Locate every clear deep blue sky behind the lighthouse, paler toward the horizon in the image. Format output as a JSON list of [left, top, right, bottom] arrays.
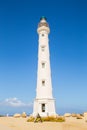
[[0, 0, 87, 114]]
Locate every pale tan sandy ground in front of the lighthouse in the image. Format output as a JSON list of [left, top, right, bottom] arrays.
[[0, 117, 87, 130]]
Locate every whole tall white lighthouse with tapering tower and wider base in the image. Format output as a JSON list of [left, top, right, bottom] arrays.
[[33, 17, 56, 116]]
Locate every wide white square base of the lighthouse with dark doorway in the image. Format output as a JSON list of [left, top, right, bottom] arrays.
[[32, 99, 56, 117]]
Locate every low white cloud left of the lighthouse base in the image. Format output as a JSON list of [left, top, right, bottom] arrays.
[[0, 97, 32, 107]]
